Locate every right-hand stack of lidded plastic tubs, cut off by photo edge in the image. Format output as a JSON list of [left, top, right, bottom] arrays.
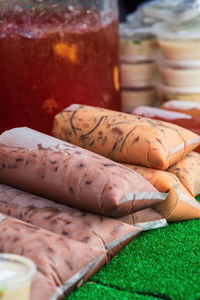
[[153, 18, 200, 102]]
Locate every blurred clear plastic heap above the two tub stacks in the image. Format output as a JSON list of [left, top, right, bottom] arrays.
[[127, 0, 200, 27]]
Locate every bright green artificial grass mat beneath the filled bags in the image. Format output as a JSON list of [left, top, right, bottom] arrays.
[[66, 196, 200, 300]]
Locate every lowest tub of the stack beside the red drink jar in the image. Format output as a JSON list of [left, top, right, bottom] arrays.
[[121, 88, 157, 113]]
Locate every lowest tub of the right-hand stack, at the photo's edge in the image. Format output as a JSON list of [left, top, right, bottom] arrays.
[[156, 84, 200, 103]]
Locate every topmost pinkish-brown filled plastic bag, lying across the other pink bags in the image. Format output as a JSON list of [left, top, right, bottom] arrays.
[[0, 125, 166, 217]]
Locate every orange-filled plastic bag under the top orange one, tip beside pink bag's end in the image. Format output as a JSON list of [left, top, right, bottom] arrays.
[[123, 164, 200, 222]]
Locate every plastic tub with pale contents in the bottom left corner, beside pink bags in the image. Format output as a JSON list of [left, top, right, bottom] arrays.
[[0, 254, 36, 300]]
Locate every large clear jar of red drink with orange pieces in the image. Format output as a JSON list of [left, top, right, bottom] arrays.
[[0, 0, 120, 134]]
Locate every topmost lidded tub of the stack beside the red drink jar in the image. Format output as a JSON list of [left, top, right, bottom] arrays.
[[120, 24, 158, 62]]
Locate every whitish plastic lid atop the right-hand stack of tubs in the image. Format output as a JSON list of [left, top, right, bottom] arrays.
[[152, 17, 200, 40]]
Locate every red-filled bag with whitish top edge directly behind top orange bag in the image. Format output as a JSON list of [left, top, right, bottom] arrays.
[[133, 106, 200, 135]]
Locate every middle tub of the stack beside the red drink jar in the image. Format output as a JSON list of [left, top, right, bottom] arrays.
[[120, 61, 157, 88]]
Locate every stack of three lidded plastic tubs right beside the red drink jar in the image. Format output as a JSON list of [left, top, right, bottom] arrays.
[[120, 24, 158, 113]]
